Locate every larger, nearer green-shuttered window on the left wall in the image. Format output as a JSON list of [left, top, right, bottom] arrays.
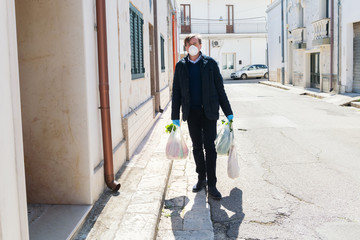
[[130, 4, 145, 79]]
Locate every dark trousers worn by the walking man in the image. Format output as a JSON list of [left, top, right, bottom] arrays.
[[188, 109, 217, 186]]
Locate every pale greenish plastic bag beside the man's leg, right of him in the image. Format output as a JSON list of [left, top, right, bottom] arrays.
[[215, 121, 234, 155]]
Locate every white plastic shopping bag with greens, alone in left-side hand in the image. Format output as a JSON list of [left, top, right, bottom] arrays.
[[166, 127, 189, 159]]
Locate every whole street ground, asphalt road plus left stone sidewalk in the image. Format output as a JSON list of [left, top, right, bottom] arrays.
[[74, 80, 360, 240]]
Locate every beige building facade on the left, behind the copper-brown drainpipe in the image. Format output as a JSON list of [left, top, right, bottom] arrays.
[[0, 0, 177, 239]]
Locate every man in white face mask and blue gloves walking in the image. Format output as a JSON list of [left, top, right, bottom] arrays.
[[171, 34, 233, 200]]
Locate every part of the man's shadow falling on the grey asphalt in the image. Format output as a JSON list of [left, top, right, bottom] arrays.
[[209, 187, 245, 239]]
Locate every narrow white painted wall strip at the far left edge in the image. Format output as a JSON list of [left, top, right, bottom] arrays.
[[0, 0, 29, 240]]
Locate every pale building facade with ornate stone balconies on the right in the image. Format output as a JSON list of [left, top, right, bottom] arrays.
[[267, 0, 360, 93]]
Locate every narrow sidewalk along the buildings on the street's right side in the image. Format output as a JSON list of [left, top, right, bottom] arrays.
[[259, 81, 360, 108]]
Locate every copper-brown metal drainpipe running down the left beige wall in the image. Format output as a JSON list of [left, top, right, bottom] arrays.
[[96, 0, 121, 192]]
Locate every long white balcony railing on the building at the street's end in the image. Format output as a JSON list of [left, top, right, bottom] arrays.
[[181, 21, 266, 34]]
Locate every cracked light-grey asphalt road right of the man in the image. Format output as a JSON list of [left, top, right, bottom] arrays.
[[209, 79, 360, 239]]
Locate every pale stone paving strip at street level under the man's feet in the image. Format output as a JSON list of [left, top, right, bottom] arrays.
[[157, 122, 214, 240]]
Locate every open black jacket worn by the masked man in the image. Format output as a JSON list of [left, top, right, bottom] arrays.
[[171, 55, 233, 121]]
